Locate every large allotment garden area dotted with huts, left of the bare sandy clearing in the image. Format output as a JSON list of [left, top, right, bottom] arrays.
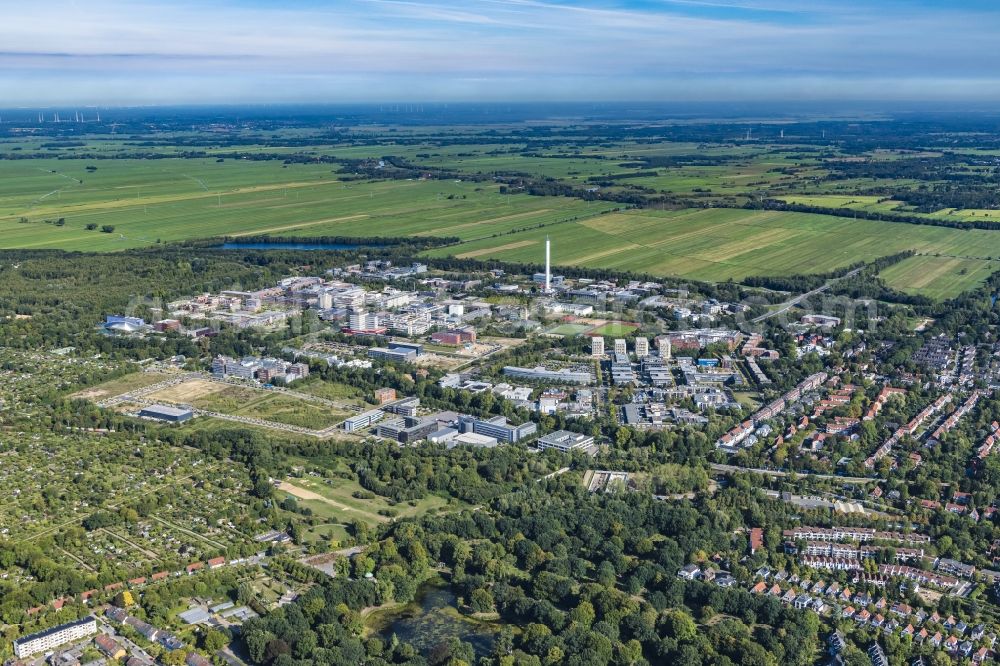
[[0, 436, 257, 576]]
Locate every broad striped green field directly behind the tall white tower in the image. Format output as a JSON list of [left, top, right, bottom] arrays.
[[428, 209, 1000, 290]]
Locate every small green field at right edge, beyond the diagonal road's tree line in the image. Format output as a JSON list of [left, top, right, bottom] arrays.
[[880, 255, 1000, 299]]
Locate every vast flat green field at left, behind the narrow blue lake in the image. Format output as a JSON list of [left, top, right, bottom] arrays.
[[0, 159, 613, 251]]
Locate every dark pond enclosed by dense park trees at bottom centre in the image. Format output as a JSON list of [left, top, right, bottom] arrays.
[[378, 584, 496, 657]]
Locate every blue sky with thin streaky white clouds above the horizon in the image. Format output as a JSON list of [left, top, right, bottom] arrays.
[[0, 0, 1000, 107]]
